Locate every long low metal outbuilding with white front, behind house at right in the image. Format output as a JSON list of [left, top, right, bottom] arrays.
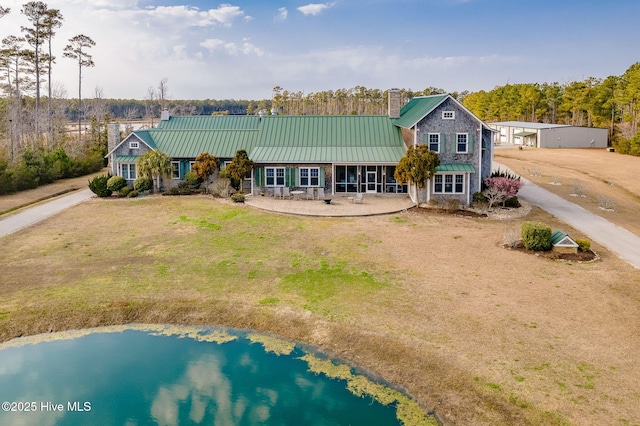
[[489, 121, 608, 148]]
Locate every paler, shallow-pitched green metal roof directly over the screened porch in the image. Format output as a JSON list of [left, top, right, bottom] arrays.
[[249, 146, 405, 164]]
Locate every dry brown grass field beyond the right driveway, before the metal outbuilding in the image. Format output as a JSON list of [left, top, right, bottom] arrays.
[[495, 148, 640, 235]]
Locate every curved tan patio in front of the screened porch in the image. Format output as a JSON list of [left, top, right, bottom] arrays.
[[245, 194, 415, 217]]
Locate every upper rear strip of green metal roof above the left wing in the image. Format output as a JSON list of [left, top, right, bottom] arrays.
[[156, 115, 260, 130]]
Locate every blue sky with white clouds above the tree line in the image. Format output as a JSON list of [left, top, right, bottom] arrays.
[[0, 0, 640, 99]]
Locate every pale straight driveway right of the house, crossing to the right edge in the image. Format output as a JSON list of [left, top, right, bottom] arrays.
[[493, 162, 640, 269]]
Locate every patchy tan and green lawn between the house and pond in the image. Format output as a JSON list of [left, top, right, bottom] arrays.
[[0, 196, 640, 425]]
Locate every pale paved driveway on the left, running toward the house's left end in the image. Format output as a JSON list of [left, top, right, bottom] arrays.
[[0, 189, 94, 238]]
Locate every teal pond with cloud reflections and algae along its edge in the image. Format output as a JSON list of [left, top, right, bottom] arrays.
[[0, 326, 420, 426]]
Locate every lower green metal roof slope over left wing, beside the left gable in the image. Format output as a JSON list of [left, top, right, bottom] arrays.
[[149, 129, 258, 158]]
